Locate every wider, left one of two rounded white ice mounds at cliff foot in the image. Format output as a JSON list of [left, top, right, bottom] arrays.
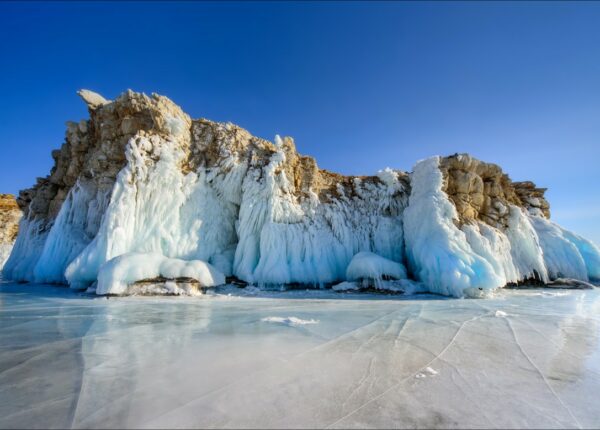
[[96, 252, 225, 294]]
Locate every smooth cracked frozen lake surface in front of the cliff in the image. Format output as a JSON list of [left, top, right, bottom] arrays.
[[0, 283, 600, 428]]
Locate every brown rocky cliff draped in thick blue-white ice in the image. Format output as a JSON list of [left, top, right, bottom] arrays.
[[4, 91, 600, 297]]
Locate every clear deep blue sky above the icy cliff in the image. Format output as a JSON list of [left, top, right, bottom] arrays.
[[0, 2, 600, 243]]
